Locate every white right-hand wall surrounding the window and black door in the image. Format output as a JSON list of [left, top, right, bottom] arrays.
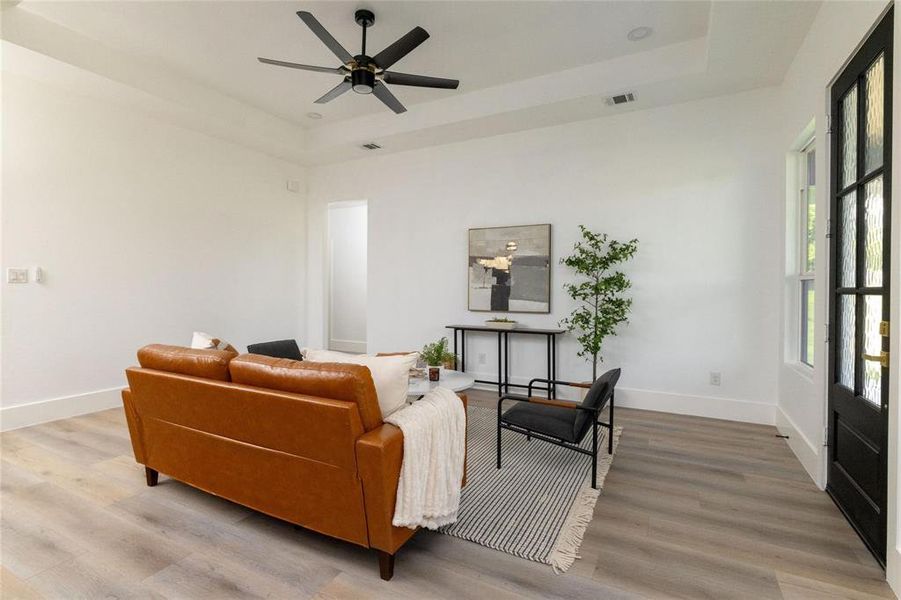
[[777, 0, 901, 593]]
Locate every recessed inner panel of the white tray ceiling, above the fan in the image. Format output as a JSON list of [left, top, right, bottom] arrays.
[[22, 1, 710, 126]]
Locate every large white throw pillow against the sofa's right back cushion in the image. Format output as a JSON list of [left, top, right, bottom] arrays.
[[303, 348, 419, 418]]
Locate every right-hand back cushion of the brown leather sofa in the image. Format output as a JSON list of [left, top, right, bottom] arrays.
[[229, 354, 382, 431]]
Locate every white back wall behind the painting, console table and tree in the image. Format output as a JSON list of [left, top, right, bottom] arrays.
[[308, 89, 783, 422]]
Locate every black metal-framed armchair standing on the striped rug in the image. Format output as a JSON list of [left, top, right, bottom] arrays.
[[497, 369, 621, 489]]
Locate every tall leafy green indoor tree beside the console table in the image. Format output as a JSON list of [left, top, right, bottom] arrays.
[[560, 225, 638, 381]]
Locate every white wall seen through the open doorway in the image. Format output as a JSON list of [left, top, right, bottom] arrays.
[[328, 201, 367, 352]]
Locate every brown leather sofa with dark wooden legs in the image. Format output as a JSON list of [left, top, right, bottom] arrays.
[[122, 345, 466, 580]]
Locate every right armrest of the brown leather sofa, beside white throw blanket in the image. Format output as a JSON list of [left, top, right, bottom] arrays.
[[357, 423, 416, 554]]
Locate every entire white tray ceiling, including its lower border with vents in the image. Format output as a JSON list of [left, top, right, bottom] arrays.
[[2, 0, 819, 163]]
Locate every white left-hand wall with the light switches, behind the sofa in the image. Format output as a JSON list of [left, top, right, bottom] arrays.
[[2, 68, 306, 428]]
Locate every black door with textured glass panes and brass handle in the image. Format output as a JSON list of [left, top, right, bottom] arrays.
[[826, 9, 894, 565]]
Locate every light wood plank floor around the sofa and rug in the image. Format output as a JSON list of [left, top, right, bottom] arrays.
[[0, 392, 892, 600]]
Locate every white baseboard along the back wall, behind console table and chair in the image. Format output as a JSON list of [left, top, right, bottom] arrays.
[[468, 371, 776, 425]]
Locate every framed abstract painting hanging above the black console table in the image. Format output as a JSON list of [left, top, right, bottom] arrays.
[[469, 225, 551, 313]]
